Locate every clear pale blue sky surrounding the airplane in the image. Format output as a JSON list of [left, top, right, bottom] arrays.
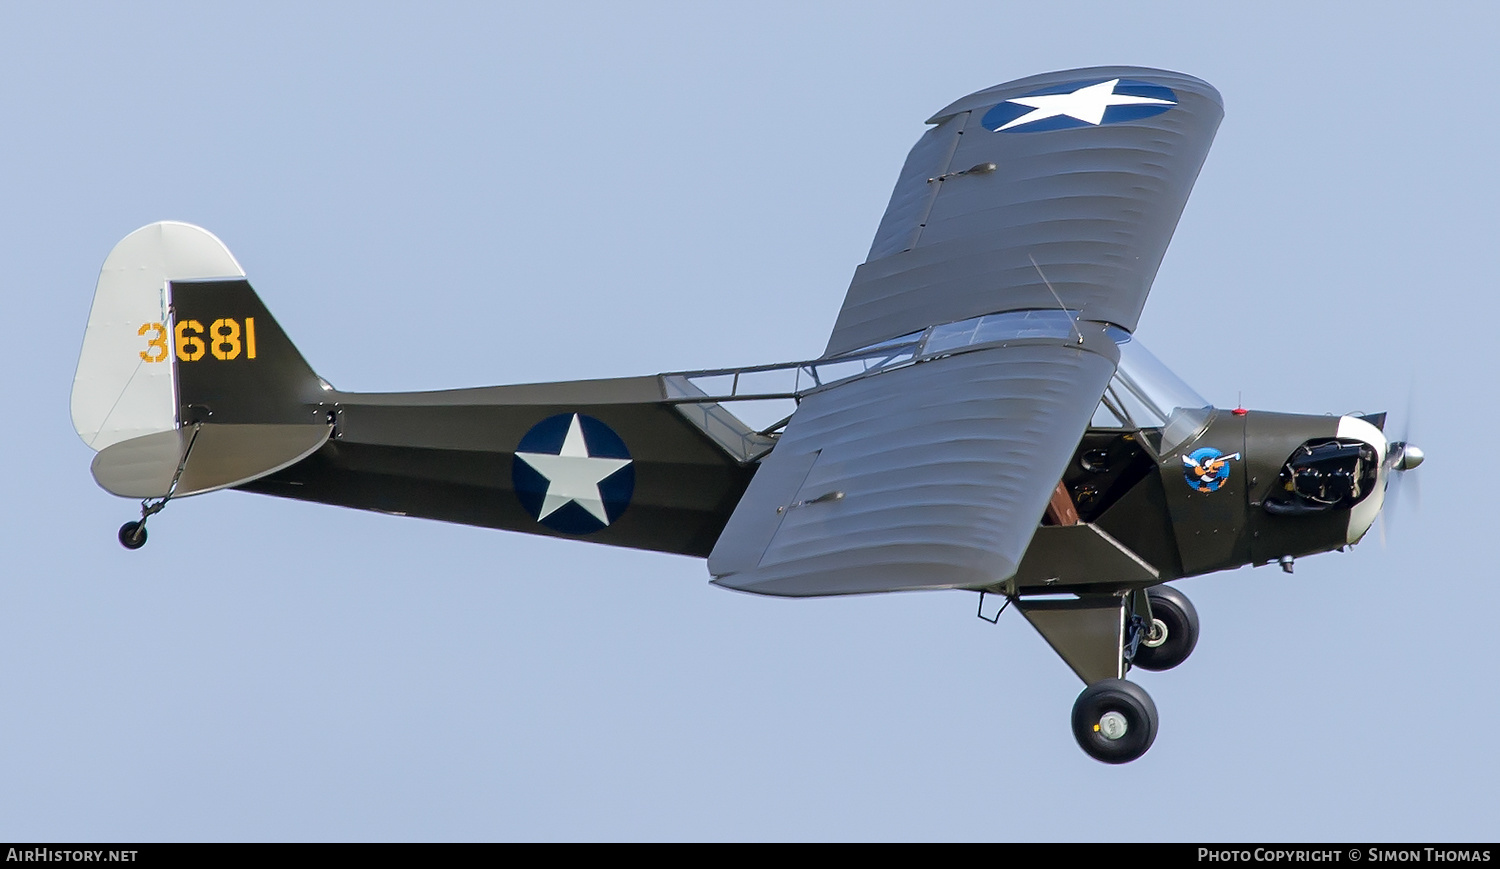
[[0, 3, 1500, 840]]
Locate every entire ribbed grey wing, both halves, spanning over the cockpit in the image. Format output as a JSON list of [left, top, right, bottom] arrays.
[[708, 68, 1223, 596]]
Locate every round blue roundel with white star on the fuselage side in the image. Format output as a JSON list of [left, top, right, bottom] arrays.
[[510, 413, 636, 534]]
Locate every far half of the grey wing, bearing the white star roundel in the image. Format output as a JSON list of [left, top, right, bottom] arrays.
[[827, 66, 1224, 354]]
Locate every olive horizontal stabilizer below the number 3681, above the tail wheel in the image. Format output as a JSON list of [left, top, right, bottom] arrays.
[[90, 423, 333, 498]]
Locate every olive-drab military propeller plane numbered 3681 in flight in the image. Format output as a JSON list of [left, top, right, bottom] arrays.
[[72, 66, 1424, 764]]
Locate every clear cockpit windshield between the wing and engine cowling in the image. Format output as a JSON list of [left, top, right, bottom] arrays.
[[1092, 336, 1214, 455]]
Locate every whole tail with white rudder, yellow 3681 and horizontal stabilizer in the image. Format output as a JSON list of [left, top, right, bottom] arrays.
[[72, 222, 329, 498]]
